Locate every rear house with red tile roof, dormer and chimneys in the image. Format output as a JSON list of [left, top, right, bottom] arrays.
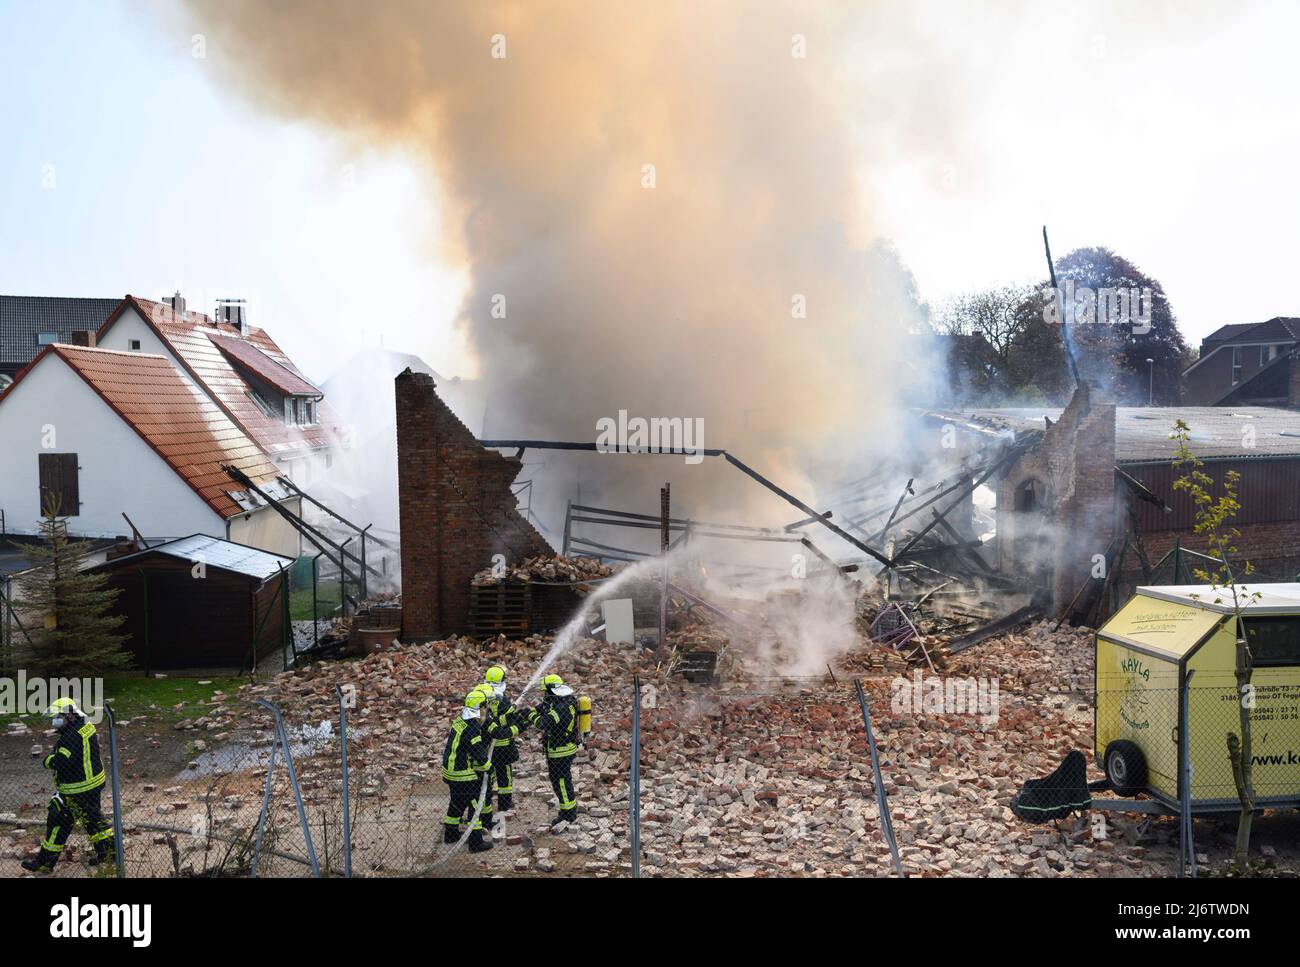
[[95, 294, 342, 486]]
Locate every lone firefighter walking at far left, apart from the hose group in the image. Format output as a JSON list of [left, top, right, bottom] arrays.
[[22, 698, 113, 873]]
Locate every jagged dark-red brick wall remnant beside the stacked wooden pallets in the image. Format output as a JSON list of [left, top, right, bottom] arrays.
[[394, 369, 554, 641]]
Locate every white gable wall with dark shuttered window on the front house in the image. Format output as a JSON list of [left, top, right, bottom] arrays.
[[0, 354, 225, 539]]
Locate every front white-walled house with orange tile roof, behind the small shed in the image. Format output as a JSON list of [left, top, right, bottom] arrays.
[[0, 343, 300, 556]]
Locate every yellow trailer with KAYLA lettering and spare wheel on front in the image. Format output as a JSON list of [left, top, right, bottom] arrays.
[[1093, 584, 1300, 812]]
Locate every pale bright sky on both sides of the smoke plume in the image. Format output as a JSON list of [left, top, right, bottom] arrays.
[[0, 0, 1300, 380]]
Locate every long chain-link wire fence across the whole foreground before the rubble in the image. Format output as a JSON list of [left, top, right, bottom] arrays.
[[20, 667, 1300, 877]]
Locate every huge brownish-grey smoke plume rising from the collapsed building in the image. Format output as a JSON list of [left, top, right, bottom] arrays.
[[175, 0, 946, 532]]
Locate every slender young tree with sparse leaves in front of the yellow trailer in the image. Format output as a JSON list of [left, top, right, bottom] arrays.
[[1170, 420, 1258, 872]]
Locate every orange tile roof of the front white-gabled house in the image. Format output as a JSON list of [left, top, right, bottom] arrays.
[[13, 346, 280, 517]]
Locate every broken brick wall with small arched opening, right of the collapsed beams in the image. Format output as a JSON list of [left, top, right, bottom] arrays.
[[997, 383, 1115, 613]]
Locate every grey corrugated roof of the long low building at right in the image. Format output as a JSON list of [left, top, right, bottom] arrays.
[[937, 407, 1300, 463]]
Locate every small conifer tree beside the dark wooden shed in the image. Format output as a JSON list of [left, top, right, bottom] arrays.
[[14, 498, 131, 676]]
